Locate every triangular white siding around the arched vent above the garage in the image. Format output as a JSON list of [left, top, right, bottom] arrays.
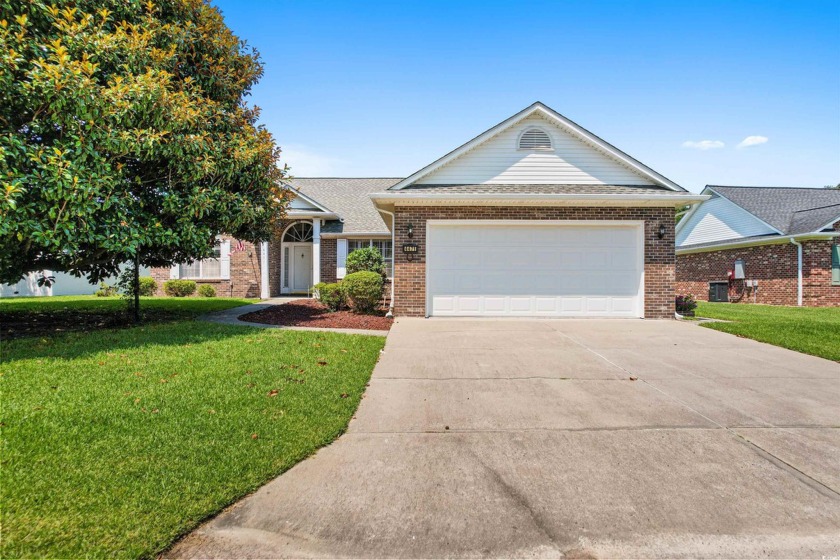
[[418, 116, 654, 185]]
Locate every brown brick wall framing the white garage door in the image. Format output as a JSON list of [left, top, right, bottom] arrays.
[[394, 206, 674, 319]]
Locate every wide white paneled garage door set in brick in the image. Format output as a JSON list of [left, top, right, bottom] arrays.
[[426, 220, 644, 317]]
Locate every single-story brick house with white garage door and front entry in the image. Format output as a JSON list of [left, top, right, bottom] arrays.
[[154, 102, 708, 318]]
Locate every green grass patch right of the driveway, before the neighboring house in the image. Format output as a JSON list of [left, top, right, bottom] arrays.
[[697, 302, 840, 362]]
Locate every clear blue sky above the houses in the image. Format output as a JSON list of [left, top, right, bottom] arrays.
[[214, 0, 840, 191]]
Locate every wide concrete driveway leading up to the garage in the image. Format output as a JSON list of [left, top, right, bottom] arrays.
[[169, 319, 840, 558]]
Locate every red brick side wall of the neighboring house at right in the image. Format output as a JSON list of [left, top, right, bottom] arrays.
[[676, 233, 840, 307]]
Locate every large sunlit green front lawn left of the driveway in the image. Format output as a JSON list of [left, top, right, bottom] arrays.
[[0, 304, 385, 558]]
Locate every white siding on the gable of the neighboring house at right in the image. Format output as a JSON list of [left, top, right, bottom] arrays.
[[676, 196, 777, 247]]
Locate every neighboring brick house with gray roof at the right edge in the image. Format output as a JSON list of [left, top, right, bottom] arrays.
[[676, 185, 840, 307]]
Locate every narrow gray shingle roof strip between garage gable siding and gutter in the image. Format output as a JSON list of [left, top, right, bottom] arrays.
[[398, 184, 680, 196]]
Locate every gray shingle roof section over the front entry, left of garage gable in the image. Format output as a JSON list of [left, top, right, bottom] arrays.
[[287, 177, 402, 234]]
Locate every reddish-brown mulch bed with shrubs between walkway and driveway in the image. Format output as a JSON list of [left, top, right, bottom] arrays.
[[239, 299, 394, 331]]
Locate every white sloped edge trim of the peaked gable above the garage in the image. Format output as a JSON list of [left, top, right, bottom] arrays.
[[389, 101, 686, 192]]
